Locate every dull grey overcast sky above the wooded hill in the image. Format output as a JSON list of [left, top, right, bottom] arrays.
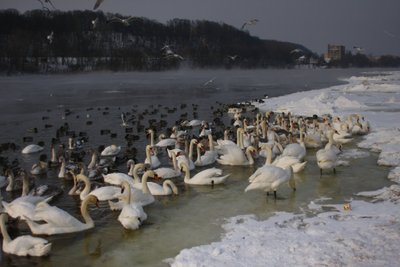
[[0, 0, 400, 56]]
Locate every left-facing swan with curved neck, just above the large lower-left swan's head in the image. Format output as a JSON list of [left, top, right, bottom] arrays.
[[76, 174, 121, 201]]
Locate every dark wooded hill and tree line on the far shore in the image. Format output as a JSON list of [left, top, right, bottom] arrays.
[[0, 9, 399, 73]]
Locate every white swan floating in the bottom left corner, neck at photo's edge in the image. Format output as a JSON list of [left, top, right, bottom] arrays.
[[0, 214, 51, 257]]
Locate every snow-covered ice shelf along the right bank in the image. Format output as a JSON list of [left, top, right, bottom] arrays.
[[166, 71, 400, 267]]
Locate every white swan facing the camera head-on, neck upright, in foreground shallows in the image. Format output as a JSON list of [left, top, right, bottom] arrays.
[[116, 181, 147, 230]]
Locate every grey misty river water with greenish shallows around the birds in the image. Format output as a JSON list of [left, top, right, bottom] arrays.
[[0, 69, 389, 266]]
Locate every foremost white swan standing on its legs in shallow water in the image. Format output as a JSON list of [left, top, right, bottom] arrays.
[[244, 166, 296, 199]]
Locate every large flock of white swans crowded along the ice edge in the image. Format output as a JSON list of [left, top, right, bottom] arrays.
[[0, 102, 369, 256]]
